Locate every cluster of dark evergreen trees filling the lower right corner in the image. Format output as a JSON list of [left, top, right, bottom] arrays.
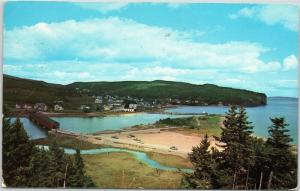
[[182, 106, 297, 189]]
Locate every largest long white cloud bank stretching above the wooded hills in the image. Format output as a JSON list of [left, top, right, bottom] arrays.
[[4, 17, 288, 73]]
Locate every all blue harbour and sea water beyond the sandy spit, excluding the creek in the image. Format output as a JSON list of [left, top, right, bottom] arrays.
[[18, 98, 298, 143]]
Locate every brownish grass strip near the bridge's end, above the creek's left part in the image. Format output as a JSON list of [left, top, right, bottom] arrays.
[[33, 134, 103, 150]]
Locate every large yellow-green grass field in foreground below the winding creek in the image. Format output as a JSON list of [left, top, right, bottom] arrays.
[[82, 153, 182, 189]]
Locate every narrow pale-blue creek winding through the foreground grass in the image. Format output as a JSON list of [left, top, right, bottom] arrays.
[[38, 146, 193, 173]]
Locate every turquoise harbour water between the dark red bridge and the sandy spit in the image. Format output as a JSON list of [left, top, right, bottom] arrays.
[[52, 113, 193, 134]]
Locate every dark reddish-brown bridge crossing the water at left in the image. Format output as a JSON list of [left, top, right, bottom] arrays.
[[29, 112, 59, 130]]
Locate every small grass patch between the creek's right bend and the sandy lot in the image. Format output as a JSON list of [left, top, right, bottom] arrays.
[[147, 152, 192, 168]]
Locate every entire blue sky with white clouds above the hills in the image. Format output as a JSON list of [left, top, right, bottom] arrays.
[[3, 2, 299, 97]]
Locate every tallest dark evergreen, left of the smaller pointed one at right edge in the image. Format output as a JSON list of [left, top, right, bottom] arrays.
[[216, 106, 254, 189]]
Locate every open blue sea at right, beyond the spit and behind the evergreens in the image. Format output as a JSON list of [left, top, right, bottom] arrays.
[[167, 97, 298, 143]]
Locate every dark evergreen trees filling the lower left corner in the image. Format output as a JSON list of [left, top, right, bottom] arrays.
[[2, 118, 94, 188]]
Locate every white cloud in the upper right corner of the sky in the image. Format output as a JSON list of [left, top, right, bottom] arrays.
[[229, 5, 299, 31]]
